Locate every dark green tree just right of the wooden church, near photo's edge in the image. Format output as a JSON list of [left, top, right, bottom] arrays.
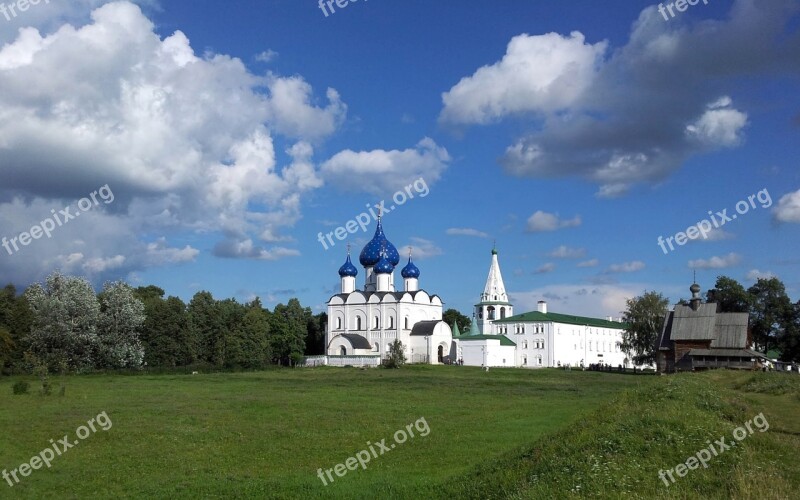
[[747, 278, 794, 353]]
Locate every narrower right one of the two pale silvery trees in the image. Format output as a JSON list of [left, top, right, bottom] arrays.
[[96, 281, 145, 368]]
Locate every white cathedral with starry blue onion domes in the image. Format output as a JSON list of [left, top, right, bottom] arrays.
[[325, 217, 453, 366]]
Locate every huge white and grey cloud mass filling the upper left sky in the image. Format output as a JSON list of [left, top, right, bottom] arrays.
[[0, 0, 347, 283]]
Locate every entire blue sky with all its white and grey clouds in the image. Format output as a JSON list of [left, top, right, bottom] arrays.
[[0, 0, 800, 317]]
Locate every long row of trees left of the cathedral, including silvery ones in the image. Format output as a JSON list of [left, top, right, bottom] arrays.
[[0, 272, 327, 374]]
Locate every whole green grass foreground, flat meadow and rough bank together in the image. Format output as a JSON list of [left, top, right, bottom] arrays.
[[0, 366, 800, 498]]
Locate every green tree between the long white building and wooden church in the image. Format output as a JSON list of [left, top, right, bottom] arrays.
[[620, 292, 669, 365]]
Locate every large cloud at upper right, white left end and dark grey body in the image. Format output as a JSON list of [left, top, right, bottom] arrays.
[[441, 0, 800, 198]]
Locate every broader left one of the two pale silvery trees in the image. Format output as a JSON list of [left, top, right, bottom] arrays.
[[24, 272, 100, 371]]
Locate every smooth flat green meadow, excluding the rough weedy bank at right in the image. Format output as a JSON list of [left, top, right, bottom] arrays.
[[0, 366, 658, 498]]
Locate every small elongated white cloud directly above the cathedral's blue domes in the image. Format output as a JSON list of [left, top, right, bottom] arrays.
[[321, 137, 450, 195]]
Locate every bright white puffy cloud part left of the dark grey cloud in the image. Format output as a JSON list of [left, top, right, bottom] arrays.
[[440, 31, 607, 123]]
